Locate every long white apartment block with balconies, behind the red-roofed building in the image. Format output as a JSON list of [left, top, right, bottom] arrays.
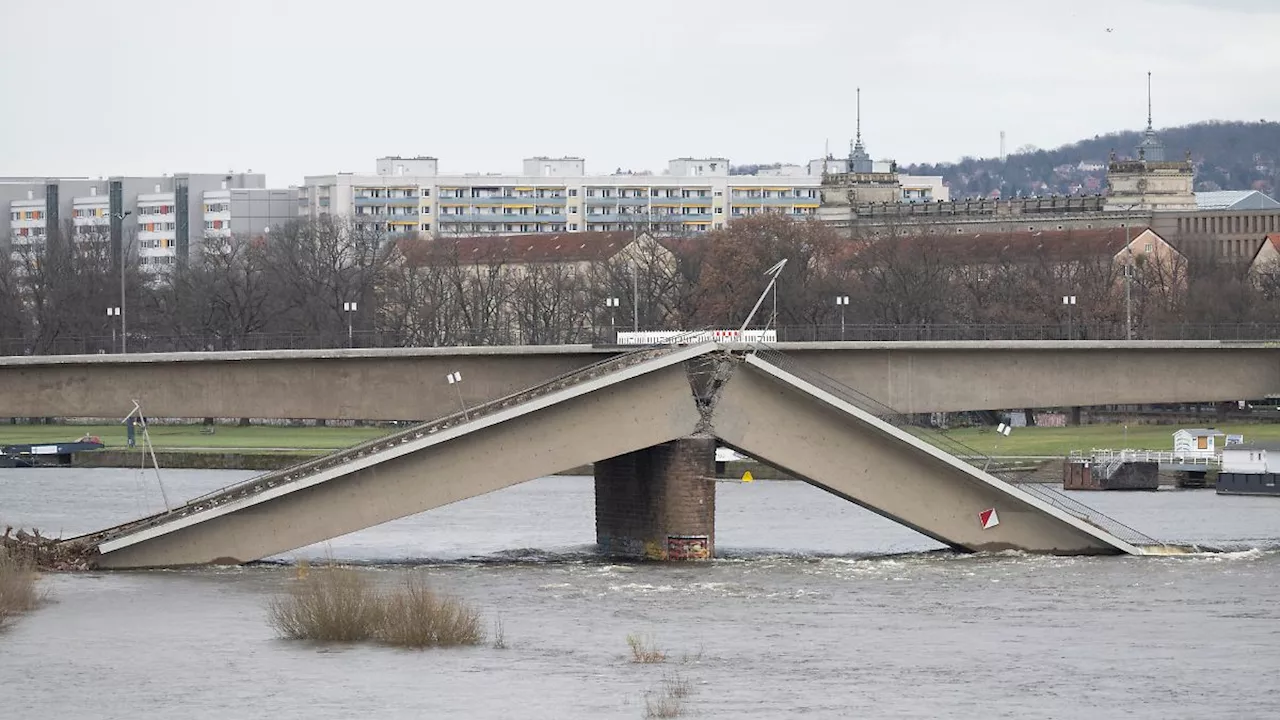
[[298, 158, 947, 236]]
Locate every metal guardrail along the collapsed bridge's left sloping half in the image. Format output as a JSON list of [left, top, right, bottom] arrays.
[[81, 331, 704, 544]]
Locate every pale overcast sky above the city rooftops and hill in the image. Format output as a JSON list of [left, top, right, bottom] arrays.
[[0, 0, 1280, 186]]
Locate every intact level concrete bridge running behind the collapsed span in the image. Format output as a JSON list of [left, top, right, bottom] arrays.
[[0, 341, 1280, 420]]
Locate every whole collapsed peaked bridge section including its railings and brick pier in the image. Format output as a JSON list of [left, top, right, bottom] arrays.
[[68, 343, 1158, 568]]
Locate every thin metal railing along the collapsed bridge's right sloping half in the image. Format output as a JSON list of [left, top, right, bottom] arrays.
[[754, 345, 1161, 546]]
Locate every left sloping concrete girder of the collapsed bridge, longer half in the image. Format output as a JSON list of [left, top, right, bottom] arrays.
[[97, 351, 701, 569]]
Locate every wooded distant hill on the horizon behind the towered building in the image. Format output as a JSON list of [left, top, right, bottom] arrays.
[[900, 120, 1280, 199]]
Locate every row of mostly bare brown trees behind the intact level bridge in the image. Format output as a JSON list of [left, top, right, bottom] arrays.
[[0, 214, 1280, 355]]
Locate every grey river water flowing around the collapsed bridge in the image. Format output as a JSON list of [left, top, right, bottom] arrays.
[[0, 469, 1280, 720]]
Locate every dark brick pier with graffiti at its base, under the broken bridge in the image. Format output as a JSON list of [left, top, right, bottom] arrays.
[[595, 438, 716, 560]]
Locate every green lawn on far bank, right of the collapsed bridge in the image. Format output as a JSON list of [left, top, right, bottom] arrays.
[[926, 423, 1280, 455]]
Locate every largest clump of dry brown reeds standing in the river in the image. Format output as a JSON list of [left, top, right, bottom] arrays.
[[268, 562, 485, 648]]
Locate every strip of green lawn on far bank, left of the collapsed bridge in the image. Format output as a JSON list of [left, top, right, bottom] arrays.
[[0, 424, 392, 450]]
